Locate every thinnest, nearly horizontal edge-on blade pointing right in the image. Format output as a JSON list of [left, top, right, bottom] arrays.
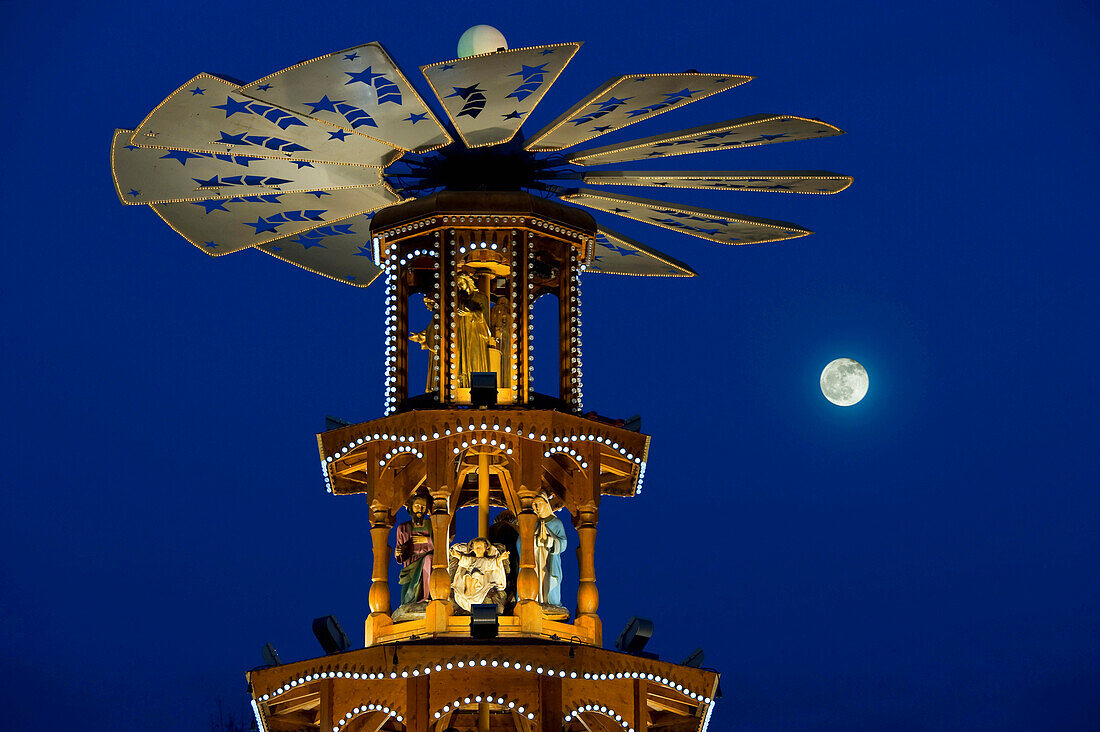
[[581, 171, 851, 195]]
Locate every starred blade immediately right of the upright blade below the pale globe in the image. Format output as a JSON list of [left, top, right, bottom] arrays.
[[525, 72, 752, 151]]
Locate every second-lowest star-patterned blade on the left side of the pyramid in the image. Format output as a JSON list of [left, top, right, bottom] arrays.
[[153, 184, 400, 256]]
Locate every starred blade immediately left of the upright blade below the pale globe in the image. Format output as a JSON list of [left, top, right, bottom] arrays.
[[240, 43, 451, 153]]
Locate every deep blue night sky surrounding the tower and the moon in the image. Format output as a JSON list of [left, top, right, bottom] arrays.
[[0, 0, 1100, 732]]
